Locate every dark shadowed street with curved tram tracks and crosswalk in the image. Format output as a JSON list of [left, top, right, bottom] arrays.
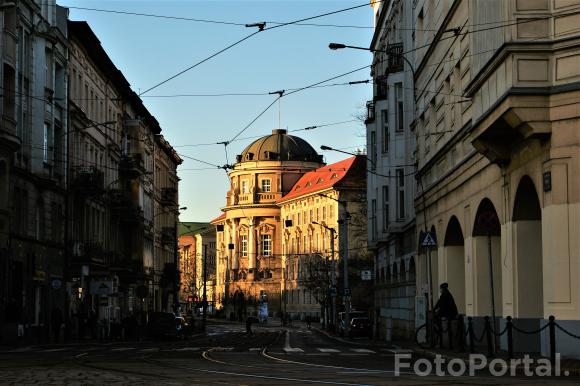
[[0, 324, 580, 386]]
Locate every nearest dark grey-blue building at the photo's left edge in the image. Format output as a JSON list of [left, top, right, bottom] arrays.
[[0, 1, 68, 341]]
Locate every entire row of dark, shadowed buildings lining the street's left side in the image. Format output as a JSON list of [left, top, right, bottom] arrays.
[[0, 5, 180, 341]]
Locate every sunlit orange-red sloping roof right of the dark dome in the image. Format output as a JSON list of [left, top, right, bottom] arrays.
[[276, 156, 366, 204]]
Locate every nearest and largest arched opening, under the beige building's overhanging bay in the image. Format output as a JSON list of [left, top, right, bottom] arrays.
[[512, 176, 544, 318]]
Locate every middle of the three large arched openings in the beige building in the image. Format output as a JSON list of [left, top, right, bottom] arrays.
[[472, 198, 503, 317]]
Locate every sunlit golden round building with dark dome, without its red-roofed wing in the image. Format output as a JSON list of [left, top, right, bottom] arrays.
[[212, 130, 324, 317]]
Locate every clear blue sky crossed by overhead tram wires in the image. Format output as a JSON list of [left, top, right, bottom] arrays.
[[57, 0, 373, 221]]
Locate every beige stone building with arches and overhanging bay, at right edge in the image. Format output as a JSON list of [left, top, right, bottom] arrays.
[[413, 0, 580, 356]]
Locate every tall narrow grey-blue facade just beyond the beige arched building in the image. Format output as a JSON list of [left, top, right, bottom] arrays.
[[365, 0, 416, 340]]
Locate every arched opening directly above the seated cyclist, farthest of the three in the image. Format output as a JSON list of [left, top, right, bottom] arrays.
[[443, 216, 465, 314]]
